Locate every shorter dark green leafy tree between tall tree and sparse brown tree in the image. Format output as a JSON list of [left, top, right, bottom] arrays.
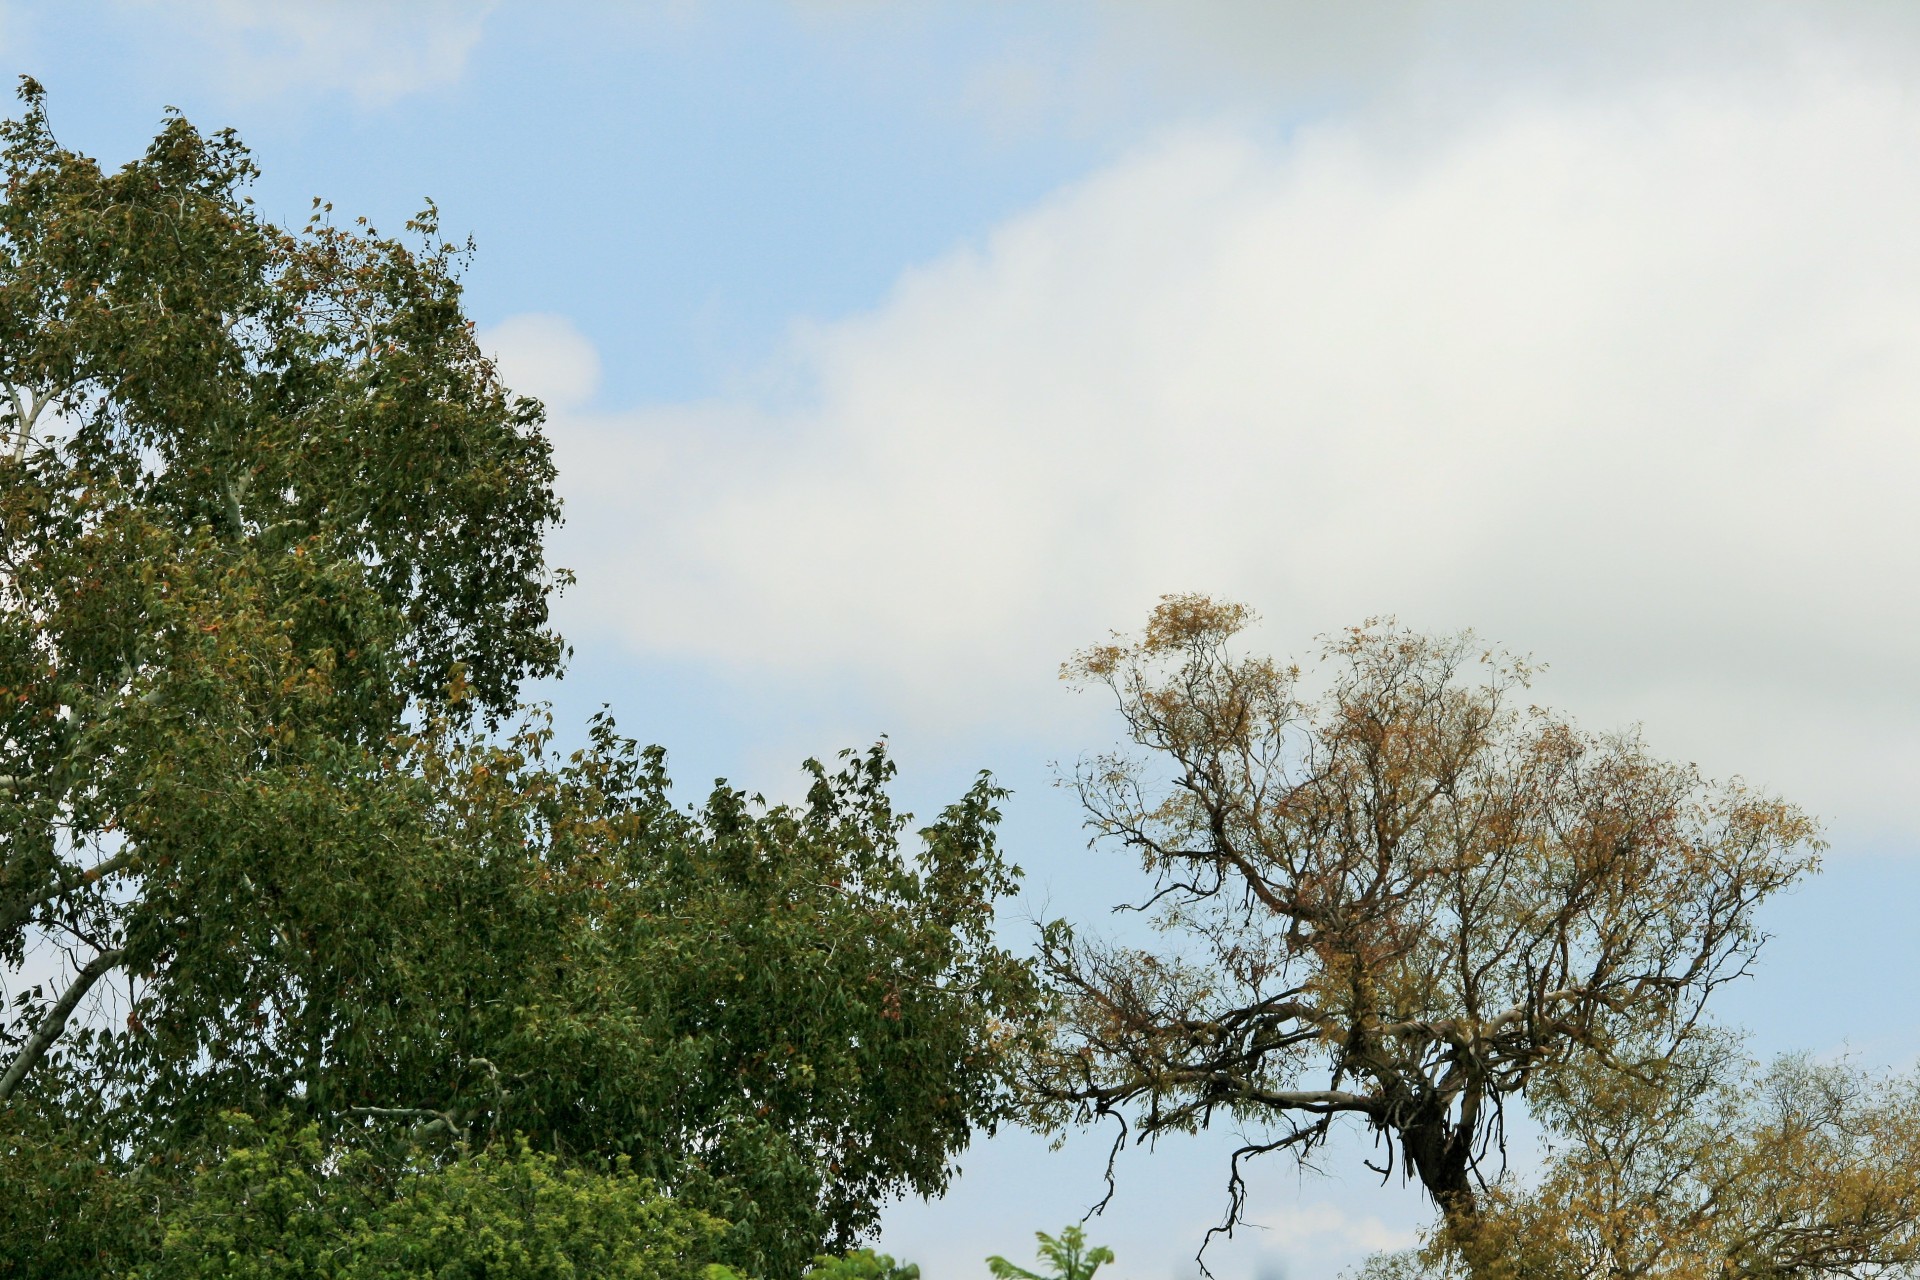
[[280, 720, 1031, 1276]]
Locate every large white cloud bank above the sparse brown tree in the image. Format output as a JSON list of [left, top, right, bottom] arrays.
[[557, 37, 1920, 831]]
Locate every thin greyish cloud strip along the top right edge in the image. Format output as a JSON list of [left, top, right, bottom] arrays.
[[791, 0, 1920, 156]]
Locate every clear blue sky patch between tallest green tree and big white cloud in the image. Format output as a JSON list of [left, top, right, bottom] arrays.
[[8, 2, 1104, 403]]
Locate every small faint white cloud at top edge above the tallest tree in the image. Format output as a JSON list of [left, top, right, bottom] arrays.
[[131, 0, 495, 106]]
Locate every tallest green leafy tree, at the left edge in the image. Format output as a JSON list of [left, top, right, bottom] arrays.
[[0, 72, 561, 1103]]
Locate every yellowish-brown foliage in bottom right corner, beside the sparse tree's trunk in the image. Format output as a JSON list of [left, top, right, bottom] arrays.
[[1363, 1036, 1920, 1280]]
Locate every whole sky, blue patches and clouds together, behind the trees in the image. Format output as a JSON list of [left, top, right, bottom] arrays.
[[11, 0, 1920, 1280]]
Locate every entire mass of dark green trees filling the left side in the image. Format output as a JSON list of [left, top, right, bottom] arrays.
[[0, 83, 1031, 1278]]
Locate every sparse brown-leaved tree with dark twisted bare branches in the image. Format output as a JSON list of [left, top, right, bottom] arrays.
[[1035, 597, 1818, 1257]]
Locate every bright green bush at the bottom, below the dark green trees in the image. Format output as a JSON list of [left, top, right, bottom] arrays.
[[140, 1115, 724, 1280]]
